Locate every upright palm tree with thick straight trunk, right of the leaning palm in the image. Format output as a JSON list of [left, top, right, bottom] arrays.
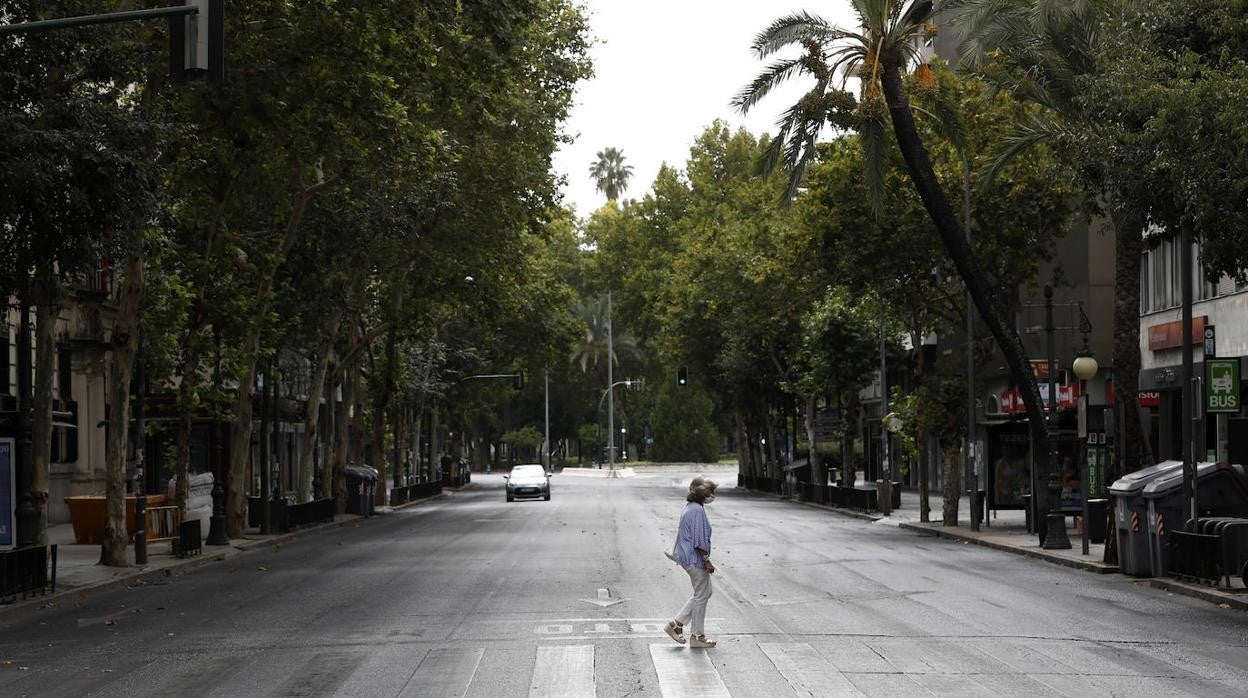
[[938, 0, 1152, 562]]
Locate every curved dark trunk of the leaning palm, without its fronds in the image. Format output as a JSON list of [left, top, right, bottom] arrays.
[[881, 59, 1050, 507]]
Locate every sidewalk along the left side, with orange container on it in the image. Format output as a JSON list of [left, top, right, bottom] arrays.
[[0, 492, 447, 629]]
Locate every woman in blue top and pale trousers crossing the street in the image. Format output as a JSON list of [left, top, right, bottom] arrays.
[[664, 477, 719, 647]]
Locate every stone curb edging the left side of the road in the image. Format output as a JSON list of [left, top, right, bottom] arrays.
[[0, 492, 447, 628]]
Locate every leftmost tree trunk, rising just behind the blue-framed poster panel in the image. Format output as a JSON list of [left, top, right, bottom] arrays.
[[31, 260, 66, 546]]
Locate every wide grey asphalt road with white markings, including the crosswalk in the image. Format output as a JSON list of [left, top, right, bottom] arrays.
[[0, 473, 1248, 698]]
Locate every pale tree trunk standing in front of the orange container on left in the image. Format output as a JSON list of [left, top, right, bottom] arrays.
[[100, 237, 144, 567]]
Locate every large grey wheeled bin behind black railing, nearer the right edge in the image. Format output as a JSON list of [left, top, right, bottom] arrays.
[[1142, 463, 1248, 577]]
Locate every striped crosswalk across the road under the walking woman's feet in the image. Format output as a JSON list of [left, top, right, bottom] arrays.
[[19, 636, 1248, 698]]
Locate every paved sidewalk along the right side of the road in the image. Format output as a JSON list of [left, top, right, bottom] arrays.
[[801, 489, 1248, 611]]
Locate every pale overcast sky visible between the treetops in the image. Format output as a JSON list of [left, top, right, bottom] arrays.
[[554, 0, 852, 217]]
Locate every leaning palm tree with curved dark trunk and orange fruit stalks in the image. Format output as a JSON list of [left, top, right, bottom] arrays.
[[734, 0, 1050, 514]]
